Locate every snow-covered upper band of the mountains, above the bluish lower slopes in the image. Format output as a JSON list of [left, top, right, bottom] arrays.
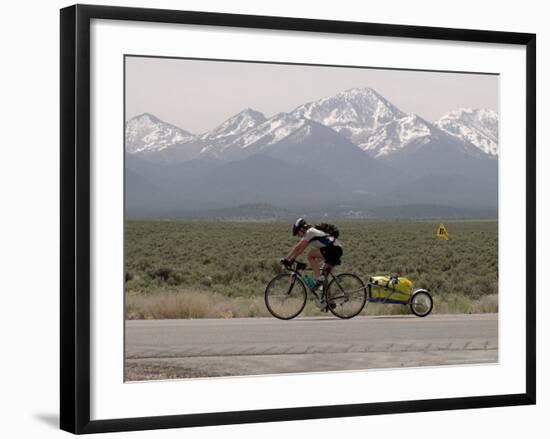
[[126, 88, 498, 166]]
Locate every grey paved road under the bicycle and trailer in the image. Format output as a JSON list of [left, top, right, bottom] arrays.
[[126, 314, 498, 381]]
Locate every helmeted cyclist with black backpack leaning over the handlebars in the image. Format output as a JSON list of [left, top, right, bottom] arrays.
[[281, 218, 342, 289]]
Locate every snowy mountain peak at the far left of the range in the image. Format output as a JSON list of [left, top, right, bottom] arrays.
[[125, 113, 194, 154]]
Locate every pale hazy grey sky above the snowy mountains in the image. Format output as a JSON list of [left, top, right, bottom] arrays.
[[126, 57, 498, 134]]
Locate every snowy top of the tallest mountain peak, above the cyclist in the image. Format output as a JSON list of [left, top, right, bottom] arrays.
[[292, 88, 406, 149]]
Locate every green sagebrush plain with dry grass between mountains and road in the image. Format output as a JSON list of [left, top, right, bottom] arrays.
[[125, 218, 498, 318]]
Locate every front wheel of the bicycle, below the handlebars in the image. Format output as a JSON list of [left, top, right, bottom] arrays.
[[265, 273, 307, 320]]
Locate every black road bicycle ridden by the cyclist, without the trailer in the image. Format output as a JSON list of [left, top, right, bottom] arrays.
[[264, 261, 367, 320]]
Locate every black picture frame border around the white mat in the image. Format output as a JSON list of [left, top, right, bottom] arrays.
[[60, 5, 536, 434]]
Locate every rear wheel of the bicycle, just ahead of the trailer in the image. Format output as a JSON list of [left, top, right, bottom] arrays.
[[326, 273, 367, 319]]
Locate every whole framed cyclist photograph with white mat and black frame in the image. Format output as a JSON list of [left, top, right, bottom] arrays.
[[61, 5, 536, 433]]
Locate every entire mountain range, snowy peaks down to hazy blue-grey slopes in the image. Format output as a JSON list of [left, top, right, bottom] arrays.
[[125, 88, 498, 217]]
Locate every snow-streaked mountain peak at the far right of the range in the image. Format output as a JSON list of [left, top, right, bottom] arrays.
[[436, 108, 498, 156]]
